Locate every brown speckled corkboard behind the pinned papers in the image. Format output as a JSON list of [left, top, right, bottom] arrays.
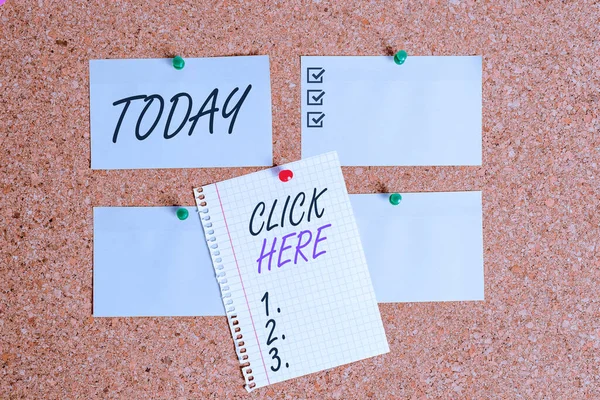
[[0, 0, 600, 399]]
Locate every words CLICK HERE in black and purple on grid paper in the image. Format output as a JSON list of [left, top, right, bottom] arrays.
[[248, 188, 331, 274]]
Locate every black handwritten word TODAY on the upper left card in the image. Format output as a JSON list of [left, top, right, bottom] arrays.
[[112, 85, 252, 143]]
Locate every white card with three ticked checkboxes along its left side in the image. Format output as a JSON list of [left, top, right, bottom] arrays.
[[301, 56, 482, 166]]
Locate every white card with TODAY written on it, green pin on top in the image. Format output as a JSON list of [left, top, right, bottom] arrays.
[[90, 56, 273, 169]]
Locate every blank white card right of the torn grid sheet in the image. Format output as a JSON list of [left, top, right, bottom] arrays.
[[351, 192, 484, 303]]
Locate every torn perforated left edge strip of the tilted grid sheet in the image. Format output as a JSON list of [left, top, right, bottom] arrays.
[[194, 188, 256, 391]]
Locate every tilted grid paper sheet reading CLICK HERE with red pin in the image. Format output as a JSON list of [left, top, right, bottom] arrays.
[[194, 152, 389, 390]]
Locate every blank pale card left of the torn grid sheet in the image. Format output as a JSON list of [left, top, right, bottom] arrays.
[[94, 207, 225, 317]]
